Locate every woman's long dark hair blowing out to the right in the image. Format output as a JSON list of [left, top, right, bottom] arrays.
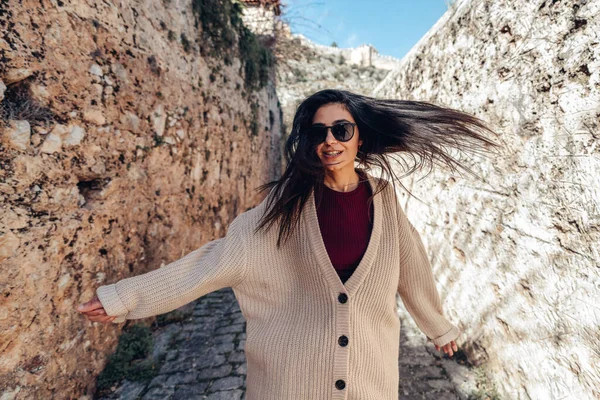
[[255, 89, 499, 248]]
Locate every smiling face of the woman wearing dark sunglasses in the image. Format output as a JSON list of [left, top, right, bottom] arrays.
[[312, 103, 362, 171]]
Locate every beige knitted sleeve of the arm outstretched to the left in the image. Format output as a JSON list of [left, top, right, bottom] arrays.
[[96, 215, 246, 323]]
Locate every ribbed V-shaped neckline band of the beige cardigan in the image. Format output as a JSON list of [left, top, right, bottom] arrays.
[[305, 172, 383, 295]]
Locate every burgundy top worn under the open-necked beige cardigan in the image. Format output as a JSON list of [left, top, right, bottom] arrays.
[[317, 181, 373, 282]]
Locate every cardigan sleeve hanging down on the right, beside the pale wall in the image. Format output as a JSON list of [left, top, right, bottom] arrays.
[[398, 206, 460, 346]]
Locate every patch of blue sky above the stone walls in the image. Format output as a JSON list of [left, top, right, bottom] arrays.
[[281, 0, 448, 58]]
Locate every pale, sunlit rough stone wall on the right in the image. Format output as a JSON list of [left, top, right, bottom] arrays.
[[373, 0, 600, 399]]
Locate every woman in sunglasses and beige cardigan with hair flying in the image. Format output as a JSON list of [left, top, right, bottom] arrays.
[[79, 90, 495, 400]]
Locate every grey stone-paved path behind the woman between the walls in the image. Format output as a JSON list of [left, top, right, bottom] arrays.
[[97, 288, 470, 400]]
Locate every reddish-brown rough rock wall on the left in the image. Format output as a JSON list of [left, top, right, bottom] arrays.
[[0, 0, 281, 399]]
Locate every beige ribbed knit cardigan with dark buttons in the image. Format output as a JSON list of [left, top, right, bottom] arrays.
[[96, 174, 460, 400]]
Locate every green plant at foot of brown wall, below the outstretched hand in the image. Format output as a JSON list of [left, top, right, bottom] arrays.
[[96, 324, 158, 392]]
